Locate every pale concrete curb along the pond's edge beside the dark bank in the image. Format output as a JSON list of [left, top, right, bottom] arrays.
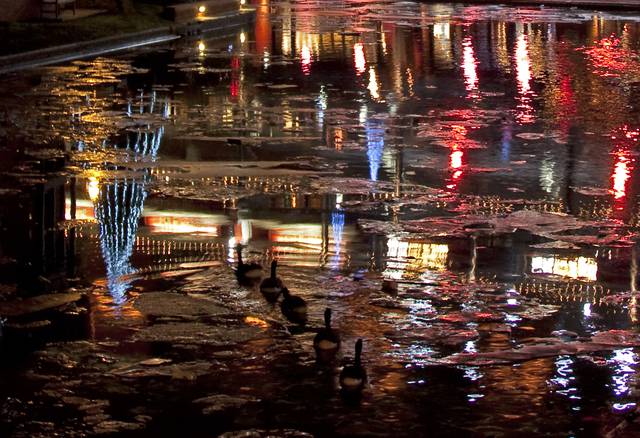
[[0, 9, 256, 74]]
